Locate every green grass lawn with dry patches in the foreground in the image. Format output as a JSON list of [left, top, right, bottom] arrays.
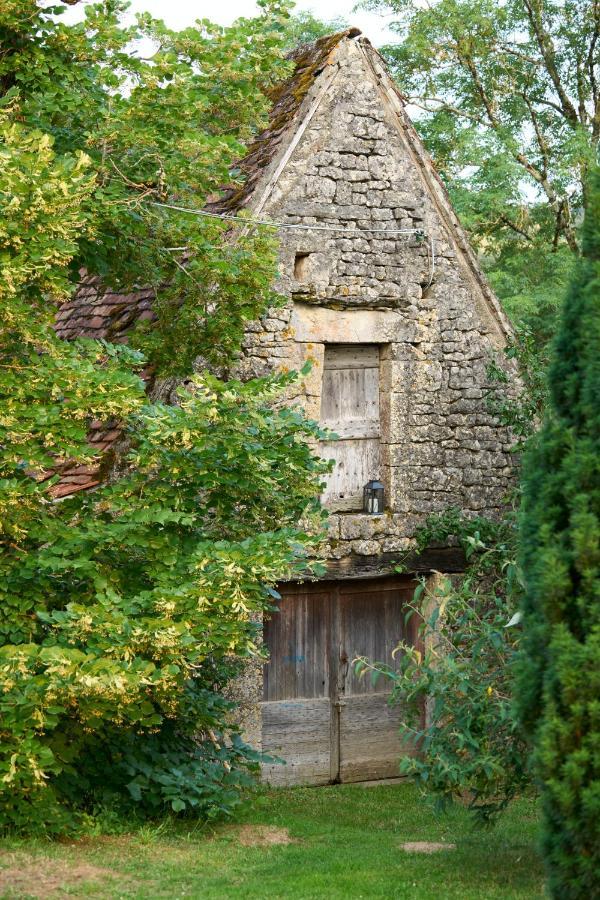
[[0, 783, 542, 900]]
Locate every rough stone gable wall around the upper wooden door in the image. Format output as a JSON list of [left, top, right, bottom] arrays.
[[231, 41, 512, 572]]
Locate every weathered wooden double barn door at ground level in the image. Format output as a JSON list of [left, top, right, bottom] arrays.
[[262, 577, 417, 785]]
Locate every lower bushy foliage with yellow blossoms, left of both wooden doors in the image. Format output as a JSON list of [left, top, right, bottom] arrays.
[[0, 375, 323, 830]]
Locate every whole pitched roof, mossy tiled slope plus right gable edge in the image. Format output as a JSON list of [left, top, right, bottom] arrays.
[[53, 28, 510, 496]]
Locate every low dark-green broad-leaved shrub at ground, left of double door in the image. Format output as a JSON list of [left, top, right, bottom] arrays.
[[54, 676, 260, 819]]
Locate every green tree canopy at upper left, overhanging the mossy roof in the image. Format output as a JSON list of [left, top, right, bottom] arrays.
[[0, 0, 289, 375]]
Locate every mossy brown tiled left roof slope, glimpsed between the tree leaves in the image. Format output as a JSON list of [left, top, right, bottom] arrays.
[[49, 28, 360, 498]]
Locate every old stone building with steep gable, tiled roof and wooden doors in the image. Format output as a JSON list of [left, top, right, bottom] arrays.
[[59, 29, 512, 784]]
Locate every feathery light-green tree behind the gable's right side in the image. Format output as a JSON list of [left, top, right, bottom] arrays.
[[360, 0, 600, 330]]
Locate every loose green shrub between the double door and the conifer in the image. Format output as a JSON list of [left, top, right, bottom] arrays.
[[357, 510, 529, 821]]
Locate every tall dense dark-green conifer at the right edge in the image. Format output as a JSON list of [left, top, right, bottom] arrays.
[[517, 174, 600, 898]]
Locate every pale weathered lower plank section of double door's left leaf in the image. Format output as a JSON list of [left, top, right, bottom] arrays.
[[261, 697, 331, 786]]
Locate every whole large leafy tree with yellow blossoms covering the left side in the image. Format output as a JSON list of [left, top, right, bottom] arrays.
[[0, 0, 323, 831]]
